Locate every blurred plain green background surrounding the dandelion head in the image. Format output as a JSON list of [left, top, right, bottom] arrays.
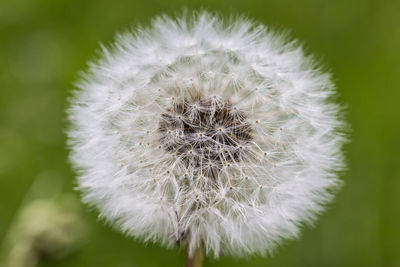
[[0, 0, 400, 267]]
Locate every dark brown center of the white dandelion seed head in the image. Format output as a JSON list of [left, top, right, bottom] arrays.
[[158, 95, 253, 169]]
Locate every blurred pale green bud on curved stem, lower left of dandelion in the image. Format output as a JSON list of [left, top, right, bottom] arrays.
[[2, 194, 85, 267]]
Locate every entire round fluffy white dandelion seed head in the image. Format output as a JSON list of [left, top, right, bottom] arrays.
[[68, 12, 345, 257]]
